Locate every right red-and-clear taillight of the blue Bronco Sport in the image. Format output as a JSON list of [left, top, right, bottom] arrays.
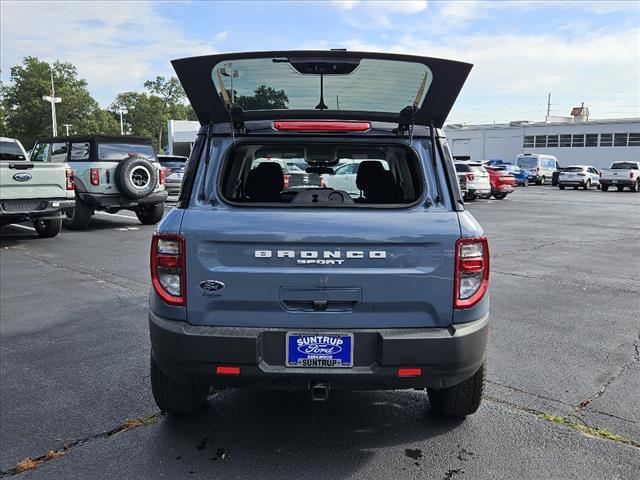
[[453, 237, 489, 308]]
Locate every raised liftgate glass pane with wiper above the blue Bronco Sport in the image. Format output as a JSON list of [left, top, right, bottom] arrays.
[[211, 58, 433, 113]]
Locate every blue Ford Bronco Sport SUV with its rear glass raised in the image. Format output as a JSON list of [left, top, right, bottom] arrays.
[[149, 51, 489, 417]]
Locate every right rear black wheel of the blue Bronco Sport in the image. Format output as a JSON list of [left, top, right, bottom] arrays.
[[427, 363, 485, 417]]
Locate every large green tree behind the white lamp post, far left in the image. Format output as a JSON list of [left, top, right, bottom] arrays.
[[0, 57, 119, 148]]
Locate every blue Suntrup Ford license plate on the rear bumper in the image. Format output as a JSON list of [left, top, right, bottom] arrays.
[[286, 332, 353, 368]]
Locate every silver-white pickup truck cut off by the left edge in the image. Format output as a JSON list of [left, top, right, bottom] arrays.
[[0, 137, 75, 238]]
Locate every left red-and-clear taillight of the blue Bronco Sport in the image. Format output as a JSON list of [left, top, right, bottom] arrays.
[[150, 233, 186, 305]]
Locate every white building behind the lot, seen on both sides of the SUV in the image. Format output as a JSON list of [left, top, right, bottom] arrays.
[[168, 107, 640, 168]]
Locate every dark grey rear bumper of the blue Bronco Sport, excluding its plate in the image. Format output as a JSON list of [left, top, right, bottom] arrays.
[[149, 311, 489, 390]]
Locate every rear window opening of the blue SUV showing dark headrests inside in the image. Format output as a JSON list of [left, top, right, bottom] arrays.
[[220, 144, 424, 207]]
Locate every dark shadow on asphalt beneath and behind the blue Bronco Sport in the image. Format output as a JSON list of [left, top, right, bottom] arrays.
[[147, 390, 462, 478]]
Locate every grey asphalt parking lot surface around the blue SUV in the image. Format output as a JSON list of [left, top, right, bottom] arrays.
[[0, 186, 640, 480]]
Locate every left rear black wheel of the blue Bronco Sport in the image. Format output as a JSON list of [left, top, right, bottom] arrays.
[[151, 356, 209, 414]]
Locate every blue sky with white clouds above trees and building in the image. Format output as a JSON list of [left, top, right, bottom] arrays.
[[0, 0, 640, 123]]
